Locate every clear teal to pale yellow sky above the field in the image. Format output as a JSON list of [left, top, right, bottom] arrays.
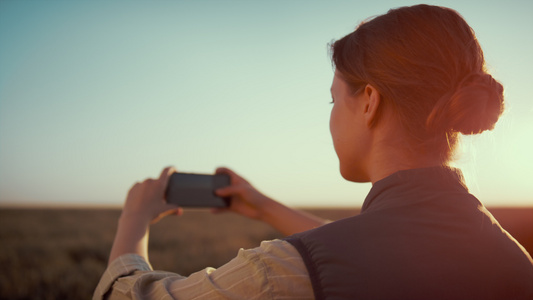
[[0, 0, 533, 206]]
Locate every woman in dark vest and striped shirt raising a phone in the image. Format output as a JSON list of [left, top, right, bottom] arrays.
[[94, 5, 533, 299]]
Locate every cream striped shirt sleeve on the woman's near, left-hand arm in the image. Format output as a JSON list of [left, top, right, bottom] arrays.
[[93, 240, 314, 300]]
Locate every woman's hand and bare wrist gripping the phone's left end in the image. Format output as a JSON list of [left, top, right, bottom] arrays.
[[109, 167, 182, 264]]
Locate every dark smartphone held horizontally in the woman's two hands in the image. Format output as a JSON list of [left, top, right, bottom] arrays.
[[165, 173, 230, 207]]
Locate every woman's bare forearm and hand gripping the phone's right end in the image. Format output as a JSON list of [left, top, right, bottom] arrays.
[[216, 168, 329, 235]]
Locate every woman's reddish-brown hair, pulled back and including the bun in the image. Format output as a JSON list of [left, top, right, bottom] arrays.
[[331, 5, 503, 168]]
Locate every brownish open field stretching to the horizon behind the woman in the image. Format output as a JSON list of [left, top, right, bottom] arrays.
[[0, 207, 533, 299]]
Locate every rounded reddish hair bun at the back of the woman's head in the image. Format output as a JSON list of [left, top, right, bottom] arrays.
[[426, 73, 504, 134]]
